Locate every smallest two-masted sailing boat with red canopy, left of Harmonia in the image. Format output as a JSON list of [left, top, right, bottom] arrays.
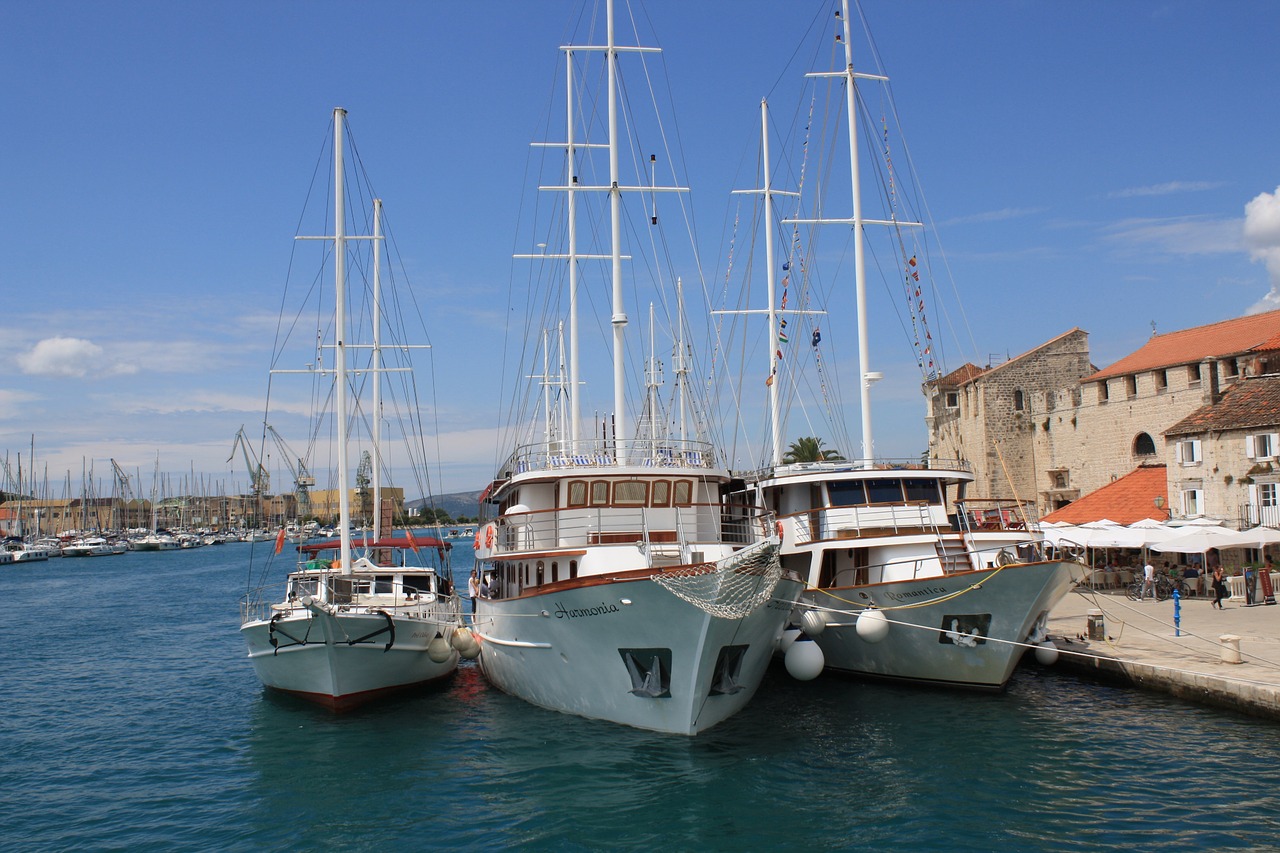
[[241, 108, 462, 711]]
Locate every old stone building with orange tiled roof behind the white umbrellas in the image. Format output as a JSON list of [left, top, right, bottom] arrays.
[[925, 311, 1280, 524]]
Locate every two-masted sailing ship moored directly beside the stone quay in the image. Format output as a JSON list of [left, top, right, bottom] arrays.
[[748, 0, 1085, 689]]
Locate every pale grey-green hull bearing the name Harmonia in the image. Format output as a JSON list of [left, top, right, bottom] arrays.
[[475, 576, 801, 735]]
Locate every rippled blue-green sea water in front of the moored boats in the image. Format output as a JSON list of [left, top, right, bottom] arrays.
[[0, 544, 1280, 850]]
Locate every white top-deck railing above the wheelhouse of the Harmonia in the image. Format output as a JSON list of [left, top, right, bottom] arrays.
[[500, 438, 716, 478]]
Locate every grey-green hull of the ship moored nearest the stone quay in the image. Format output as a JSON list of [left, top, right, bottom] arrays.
[[800, 561, 1085, 690]]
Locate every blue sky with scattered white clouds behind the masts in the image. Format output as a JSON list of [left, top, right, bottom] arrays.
[[0, 0, 1280, 502]]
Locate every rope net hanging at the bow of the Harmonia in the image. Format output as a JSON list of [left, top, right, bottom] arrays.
[[653, 540, 782, 619]]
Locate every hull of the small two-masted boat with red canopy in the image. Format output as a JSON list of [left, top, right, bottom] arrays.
[[241, 611, 458, 711]]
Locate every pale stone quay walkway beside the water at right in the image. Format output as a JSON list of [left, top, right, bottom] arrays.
[[1048, 588, 1280, 720]]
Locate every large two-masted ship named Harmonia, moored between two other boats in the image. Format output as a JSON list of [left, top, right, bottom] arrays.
[[474, 3, 800, 735]]
